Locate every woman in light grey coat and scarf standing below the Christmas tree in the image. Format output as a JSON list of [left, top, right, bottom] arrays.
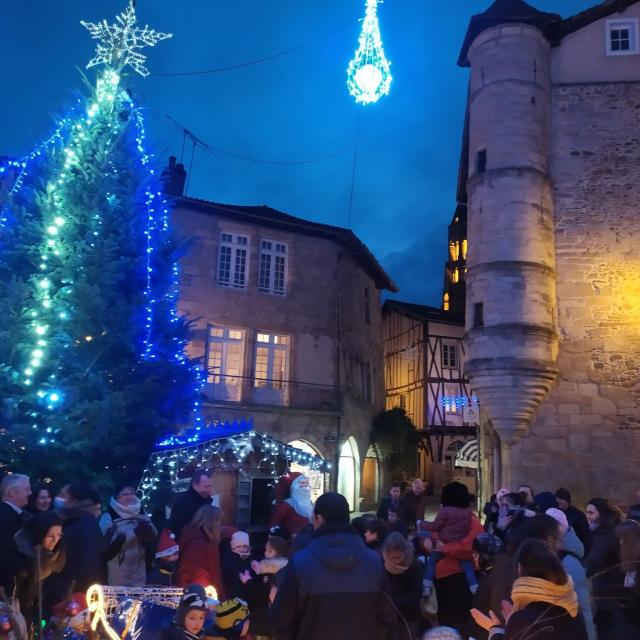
[[99, 486, 158, 587]]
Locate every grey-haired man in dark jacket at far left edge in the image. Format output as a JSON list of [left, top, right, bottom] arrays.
[[0, 473, 31, 594]]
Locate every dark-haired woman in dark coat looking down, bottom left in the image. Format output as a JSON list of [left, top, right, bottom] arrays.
[[11, 511, 65, 629]]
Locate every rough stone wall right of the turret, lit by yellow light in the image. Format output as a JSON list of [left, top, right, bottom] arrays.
[[502, 82, 640, 504]]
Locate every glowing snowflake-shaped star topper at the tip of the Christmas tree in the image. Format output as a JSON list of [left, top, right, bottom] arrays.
[[80, 0, 173, 76]]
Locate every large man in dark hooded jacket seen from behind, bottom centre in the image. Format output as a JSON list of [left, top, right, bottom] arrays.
[[269, 492, 396, 640]]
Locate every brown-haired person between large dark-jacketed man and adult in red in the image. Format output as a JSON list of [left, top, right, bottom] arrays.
[[382, 533, 424, 640]]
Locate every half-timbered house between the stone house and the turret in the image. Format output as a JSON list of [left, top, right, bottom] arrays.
[[382, 300, 478, 495]]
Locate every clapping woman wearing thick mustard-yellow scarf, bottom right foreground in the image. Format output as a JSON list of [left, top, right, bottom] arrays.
[[471, 540, 587, 640]]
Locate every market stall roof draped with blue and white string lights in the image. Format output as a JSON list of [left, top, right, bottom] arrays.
[[138, 419, 331, 504]]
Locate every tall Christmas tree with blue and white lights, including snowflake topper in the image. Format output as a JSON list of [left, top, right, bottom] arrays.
[[0, 0, 201, 484]]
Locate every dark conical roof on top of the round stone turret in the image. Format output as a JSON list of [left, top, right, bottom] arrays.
[[458, 0, 562, 67]]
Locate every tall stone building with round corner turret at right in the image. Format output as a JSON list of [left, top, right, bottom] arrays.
[[459, 0, 640, 503]]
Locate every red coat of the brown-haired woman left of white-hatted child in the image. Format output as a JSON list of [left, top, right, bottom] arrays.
[[176, 524, 227, 600]]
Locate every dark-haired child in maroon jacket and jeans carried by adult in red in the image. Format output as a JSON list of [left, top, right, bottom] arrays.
[[418, 482, 478, 597]]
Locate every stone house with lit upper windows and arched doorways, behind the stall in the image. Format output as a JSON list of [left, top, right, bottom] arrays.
[[163, 158, 396, 510]]
